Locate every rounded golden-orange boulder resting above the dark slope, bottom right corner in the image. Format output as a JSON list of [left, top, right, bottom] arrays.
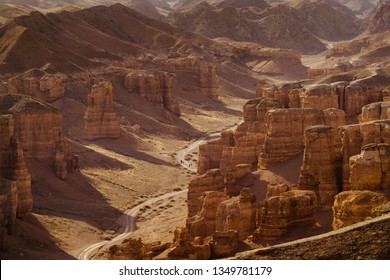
[[333, 190, 388, 229]]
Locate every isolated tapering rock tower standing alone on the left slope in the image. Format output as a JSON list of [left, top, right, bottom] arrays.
[[84, 82, 120, 140]]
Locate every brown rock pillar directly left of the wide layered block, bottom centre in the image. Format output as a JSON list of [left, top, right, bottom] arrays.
[[216, 188, 256, 239]]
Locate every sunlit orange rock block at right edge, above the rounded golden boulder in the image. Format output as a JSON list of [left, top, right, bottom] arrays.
[[349, 143, 390, 191]]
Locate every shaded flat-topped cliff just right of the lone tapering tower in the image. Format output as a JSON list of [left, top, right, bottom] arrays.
[[124, 70, 180, 115]]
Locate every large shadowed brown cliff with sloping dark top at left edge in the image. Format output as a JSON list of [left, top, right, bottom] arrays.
[[0, 95, 73, 179]]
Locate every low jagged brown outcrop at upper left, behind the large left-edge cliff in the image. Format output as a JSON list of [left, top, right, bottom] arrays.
[[11, 69, 66, 102]]
